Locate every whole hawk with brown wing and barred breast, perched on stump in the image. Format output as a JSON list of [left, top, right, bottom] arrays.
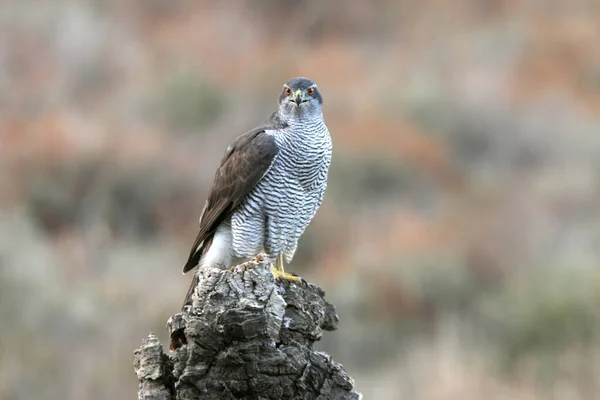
[[183, 78, 332, 305]]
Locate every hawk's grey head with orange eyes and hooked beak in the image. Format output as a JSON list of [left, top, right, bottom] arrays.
[[279, 78, 323, 119]]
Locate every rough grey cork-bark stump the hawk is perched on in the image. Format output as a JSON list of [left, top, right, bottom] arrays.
[[134, 256, 361, 400]]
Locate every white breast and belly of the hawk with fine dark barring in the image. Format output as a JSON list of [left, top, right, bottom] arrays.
[[231, 119, 332, 263]]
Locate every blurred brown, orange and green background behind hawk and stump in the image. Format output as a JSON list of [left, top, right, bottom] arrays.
[[0, 0, 600, 400]]
